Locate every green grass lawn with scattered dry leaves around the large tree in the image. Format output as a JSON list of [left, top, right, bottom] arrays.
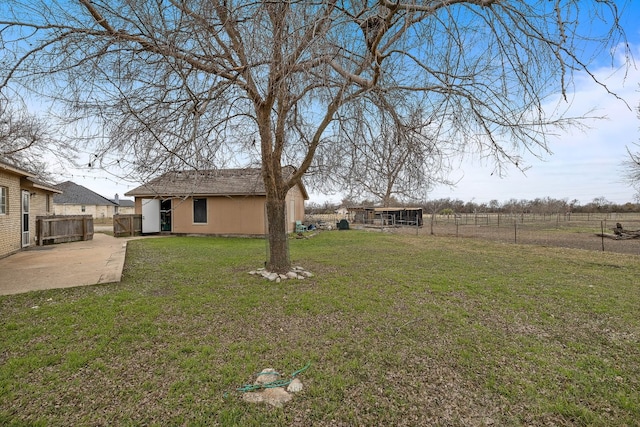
[[0, 230, 640, 426]]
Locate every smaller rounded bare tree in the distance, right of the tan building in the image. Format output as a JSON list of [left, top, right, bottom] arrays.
[[320, 100, 452, 207]]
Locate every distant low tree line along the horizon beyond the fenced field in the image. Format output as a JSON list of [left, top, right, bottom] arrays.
[[306, 197, 640, 215]]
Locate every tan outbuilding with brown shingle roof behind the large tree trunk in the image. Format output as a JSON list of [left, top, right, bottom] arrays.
[[125, 166, 309, 236]]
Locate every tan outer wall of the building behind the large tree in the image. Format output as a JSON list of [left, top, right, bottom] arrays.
[[135, 187, 304, 236]]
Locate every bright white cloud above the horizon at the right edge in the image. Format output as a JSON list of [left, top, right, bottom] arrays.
[[429, 42, 640, 203]]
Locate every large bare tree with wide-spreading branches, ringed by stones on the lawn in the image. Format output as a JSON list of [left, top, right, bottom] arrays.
[[0, 0, 624, 271]]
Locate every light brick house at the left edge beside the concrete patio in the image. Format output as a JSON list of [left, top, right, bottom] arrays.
[[0, 160, 61, 258]]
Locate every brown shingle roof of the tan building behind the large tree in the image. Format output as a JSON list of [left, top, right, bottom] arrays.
[[125, 166, 309, 199]]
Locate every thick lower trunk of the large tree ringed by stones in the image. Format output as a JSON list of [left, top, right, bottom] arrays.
[[267, 197, 291, 273]]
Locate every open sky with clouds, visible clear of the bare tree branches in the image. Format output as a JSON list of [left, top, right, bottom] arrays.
[[48, 2, 640, 204]]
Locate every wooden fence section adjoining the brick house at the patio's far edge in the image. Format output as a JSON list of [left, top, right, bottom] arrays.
[[36, 215, 93, 246]]
